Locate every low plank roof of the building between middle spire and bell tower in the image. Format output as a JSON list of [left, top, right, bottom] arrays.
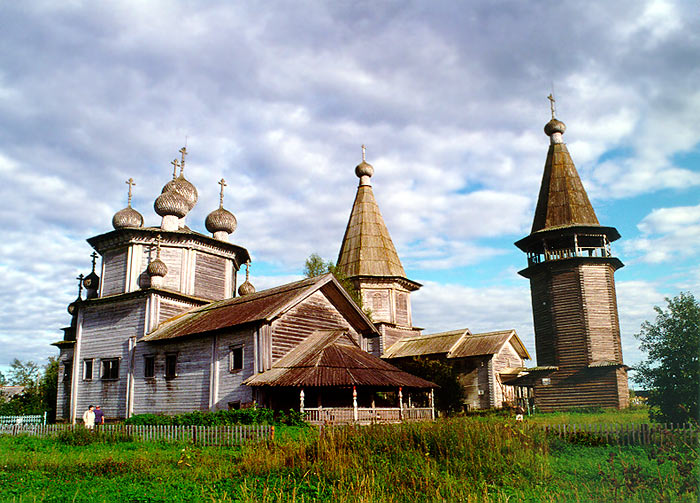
[[383, 328, 531, 360]]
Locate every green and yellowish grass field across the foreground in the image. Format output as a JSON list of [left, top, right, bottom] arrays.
[[0, 412, 698, 503]]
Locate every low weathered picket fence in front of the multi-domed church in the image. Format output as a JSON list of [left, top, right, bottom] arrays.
[[0, 424, 275, 446]]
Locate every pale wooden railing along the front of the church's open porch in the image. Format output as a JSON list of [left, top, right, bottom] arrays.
[[304, 407, 433, 424]]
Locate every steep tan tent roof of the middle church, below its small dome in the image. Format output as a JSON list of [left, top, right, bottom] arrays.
[[337, 185, 406, 278]]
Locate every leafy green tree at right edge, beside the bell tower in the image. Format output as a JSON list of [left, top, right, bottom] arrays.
[[634, 292, 700, 423]]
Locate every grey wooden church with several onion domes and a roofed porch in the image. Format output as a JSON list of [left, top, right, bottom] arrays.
[[55, 148, 435, 422]]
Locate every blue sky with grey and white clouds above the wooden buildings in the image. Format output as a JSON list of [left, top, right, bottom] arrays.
[[0, 0, 700, 382]]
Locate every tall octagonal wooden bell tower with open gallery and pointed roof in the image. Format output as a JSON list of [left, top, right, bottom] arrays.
[[515, 100, 629, 410]]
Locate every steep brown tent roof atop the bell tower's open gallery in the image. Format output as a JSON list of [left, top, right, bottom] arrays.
[[531, 143, 600, 233]]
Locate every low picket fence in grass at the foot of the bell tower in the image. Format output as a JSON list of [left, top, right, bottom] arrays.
[[542, 423, 700, 445]]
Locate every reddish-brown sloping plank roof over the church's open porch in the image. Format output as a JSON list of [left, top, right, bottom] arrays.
[[244, 330, 437, 388]]
